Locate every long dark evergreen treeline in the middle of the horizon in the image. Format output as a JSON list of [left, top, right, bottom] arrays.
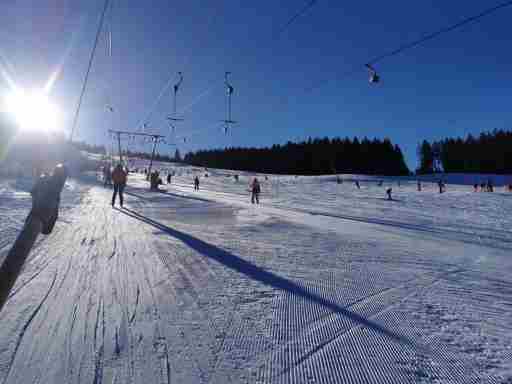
[[184, 138, 409, 176]]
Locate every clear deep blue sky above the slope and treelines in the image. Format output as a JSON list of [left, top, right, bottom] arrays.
[[0, 0, 512, 169]]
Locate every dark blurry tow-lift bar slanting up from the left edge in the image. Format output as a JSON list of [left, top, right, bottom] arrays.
[[0, 164, 67, 311]]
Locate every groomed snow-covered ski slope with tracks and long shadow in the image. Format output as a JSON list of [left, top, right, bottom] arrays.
[[0, 164, 512, 384]]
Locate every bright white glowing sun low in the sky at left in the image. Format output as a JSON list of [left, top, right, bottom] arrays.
[[4, 90, 61, 133]]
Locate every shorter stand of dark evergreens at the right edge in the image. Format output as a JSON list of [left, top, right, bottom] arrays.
[[417, 130, 512, 174]]
